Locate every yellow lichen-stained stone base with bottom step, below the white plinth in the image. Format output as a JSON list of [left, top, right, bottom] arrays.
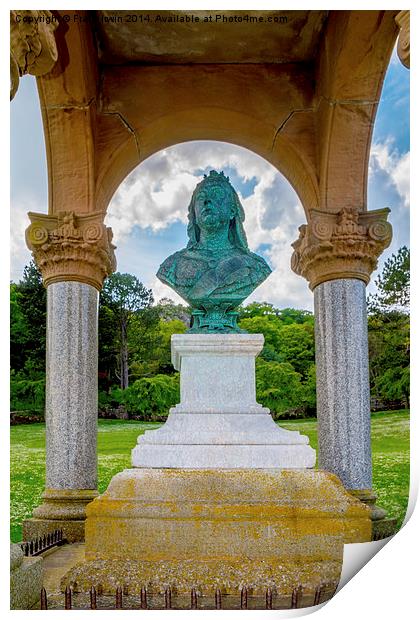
[[62, 469, 371, 594]]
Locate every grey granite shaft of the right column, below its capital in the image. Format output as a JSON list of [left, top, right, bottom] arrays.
[[314, 278, 372, 490]]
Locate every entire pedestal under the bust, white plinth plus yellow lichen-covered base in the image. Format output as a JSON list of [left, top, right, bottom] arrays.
[[62, 334, 371, 596]]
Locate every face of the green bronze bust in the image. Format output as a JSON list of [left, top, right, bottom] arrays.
[[194, 185, 234, 232]]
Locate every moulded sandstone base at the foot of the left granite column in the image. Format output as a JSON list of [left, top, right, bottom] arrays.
[[23, 489, 98, 543]]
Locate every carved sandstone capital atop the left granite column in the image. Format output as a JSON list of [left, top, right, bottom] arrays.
[[26, 211, 116, 291]]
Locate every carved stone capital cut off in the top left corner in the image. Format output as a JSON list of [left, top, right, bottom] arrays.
[[10, 10, 58, 99]]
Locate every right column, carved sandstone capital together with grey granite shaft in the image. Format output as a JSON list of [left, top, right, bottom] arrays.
[[292, 209, 392, 536]]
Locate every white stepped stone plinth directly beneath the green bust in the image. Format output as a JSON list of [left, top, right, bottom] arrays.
[[132, 334, 315, 469]]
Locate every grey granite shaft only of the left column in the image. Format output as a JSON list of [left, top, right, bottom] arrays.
[[45, 282, 98, 489]]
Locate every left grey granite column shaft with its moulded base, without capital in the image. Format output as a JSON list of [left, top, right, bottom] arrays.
[[23, 282, 98, 542]]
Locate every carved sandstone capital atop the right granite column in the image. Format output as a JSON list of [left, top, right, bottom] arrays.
[[291, 208, 392, 290]]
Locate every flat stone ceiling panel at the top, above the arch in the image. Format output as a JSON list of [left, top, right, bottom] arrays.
[[93, 10, 328, 64]]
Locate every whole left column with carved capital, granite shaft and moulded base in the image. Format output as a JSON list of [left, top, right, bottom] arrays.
[[24, 212, 115, 542]]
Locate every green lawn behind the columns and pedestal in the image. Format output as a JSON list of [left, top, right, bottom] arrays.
[[10, 411, 410, 542]]
